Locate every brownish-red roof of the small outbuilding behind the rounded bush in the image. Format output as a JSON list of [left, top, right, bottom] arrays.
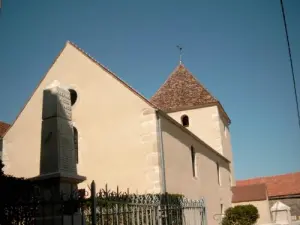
[[232, 184, 268, 203]]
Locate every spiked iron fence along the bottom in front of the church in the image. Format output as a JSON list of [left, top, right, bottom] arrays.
[[0, 182, 206, 225]]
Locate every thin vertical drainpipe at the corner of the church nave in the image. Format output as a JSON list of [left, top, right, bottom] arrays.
[[156, 111, 167, 193]]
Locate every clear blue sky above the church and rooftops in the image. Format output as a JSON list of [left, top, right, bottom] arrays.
[[0, 0, 300, 179]]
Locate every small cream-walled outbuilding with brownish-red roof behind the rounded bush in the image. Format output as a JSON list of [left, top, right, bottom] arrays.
[[232, 184, 272, 224]]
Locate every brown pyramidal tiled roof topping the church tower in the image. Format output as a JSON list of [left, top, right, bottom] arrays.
[[150, 64, 218, 112]]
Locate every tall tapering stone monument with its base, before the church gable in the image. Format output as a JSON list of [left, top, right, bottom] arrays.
[[32, 84, 86, 225]]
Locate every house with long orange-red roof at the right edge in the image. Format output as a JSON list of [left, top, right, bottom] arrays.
[[237, 172, 300, 221]]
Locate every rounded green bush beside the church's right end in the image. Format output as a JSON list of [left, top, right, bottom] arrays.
[[222, 204, 259, 225]]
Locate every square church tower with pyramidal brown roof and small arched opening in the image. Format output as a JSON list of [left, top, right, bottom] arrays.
[[150, 63, 235, 185]]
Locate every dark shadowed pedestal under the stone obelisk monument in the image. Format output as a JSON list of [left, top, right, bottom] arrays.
[[31, 173, 86, 225]]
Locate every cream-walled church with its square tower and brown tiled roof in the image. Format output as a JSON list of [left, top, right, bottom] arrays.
[[4, 42, 235, 224]]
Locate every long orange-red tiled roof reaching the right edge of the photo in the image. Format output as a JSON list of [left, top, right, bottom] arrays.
[[236, 172, 300, 197]]
